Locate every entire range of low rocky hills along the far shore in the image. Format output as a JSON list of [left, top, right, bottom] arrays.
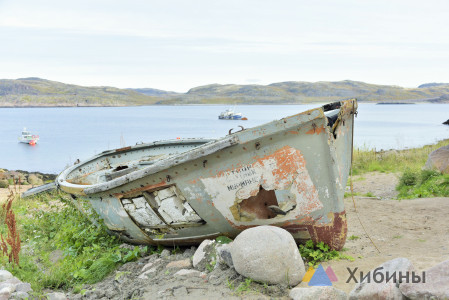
[[0, 78, 449, 106]]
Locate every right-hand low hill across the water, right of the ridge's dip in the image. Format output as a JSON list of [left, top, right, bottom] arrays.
[[175, 80, 449, 104]]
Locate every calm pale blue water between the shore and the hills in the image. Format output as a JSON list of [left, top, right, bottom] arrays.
[[0, 104, 449, 173]]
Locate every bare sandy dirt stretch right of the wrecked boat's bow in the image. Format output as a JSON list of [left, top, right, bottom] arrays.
[[312, 173, 449, 292]]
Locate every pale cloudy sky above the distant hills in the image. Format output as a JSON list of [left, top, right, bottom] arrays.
[[0, 0, 449, 92]]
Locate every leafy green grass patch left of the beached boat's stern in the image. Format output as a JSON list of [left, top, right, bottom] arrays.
[[0, 192, 146, 292]]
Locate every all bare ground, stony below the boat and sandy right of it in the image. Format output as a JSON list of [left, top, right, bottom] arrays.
[[0, 173, 449, 299]]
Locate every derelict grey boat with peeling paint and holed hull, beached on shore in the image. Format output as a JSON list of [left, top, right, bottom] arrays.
[[56, 99, 357, 249]]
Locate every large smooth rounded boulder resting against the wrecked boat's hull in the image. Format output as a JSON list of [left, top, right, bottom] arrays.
[[231, 226, 306, 285]]
